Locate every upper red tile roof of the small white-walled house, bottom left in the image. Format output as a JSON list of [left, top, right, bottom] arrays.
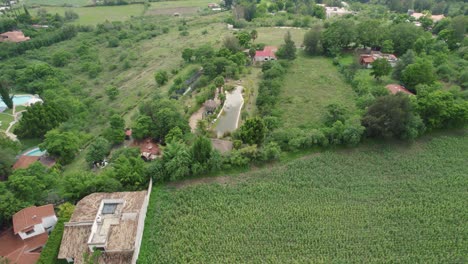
[[13, 204, 55, 234]]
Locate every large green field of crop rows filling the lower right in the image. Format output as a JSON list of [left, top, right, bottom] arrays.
[[139, 131, 468, 263]]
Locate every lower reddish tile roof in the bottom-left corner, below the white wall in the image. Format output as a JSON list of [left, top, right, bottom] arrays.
[[0, 229, 48, 264]]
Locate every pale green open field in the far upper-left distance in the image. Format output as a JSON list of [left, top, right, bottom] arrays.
[[40, 4, 144, 25]]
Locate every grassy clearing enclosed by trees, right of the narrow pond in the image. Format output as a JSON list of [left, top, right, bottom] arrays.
[[278, 55, 354, 127]]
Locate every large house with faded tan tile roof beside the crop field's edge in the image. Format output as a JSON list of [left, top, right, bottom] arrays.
[[58, 190, 150, 264]]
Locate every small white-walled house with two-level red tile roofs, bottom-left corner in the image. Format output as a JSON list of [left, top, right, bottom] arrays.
[[0, 204, 57, 264]]
